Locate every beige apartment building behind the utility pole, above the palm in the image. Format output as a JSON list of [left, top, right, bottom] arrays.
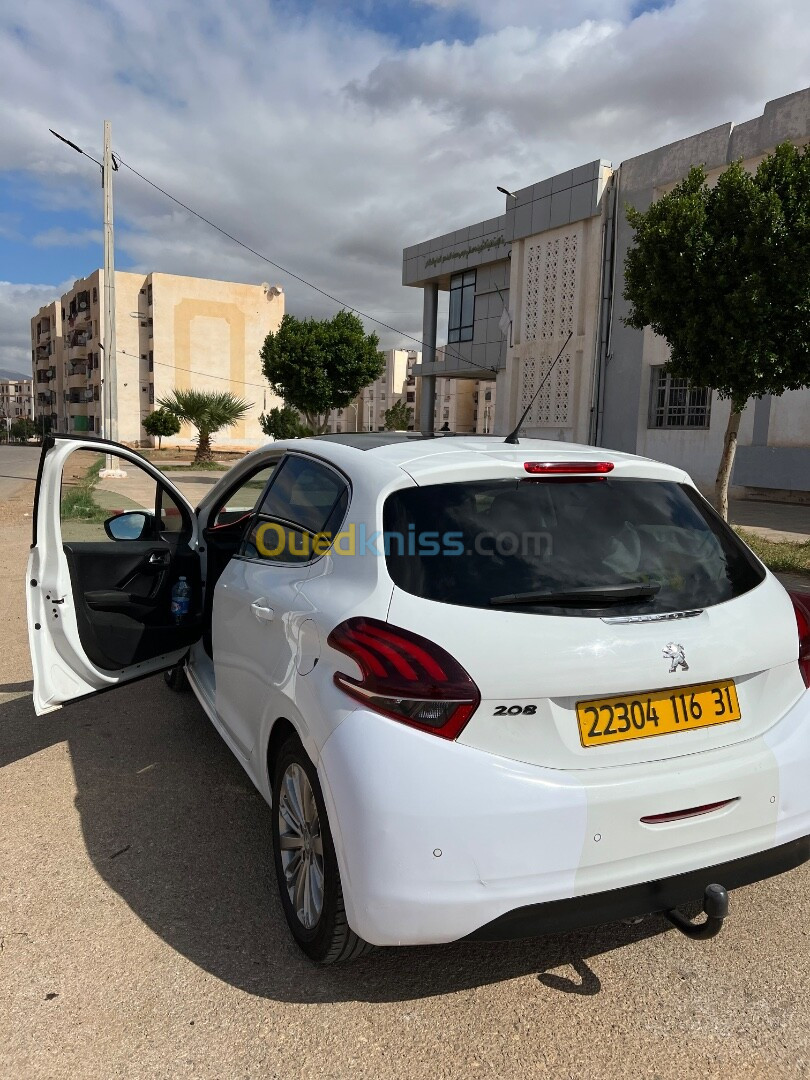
[[31, 270, 284, 449]]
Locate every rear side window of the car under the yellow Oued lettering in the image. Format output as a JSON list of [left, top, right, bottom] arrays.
[[242, 456, 349, 563]]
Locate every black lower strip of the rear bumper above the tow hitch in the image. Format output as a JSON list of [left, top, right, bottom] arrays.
[[467, 836, 810, 942]]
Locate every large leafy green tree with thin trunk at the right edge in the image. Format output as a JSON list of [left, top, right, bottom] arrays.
[[624, 143, 810, 518]]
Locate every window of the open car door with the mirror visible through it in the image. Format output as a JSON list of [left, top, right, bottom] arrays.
[[59, 449, 190, 543]]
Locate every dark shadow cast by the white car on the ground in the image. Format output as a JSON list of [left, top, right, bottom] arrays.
[[0, 676, 669, 1003]]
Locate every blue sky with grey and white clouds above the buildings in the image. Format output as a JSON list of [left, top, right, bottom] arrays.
[[0, 0, 810, 370]]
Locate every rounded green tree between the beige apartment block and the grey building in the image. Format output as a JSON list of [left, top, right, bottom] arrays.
[[261, 311, 384, 435]]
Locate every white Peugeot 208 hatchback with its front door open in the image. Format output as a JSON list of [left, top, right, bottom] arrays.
[[27, 434, 810, 962]]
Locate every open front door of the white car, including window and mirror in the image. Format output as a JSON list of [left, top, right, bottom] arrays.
[[26, 435, 202, 715]]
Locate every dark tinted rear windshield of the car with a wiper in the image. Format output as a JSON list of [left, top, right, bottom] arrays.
[[383, 477, 765, 618]]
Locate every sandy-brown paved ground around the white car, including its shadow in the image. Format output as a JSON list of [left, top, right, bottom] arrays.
[[0, 475, 810, 1080]]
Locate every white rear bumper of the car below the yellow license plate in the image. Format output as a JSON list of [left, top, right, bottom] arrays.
[[319, 691, 810, 945]]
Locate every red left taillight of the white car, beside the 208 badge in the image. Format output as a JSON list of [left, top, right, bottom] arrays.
[[327, 618, 481, 739]]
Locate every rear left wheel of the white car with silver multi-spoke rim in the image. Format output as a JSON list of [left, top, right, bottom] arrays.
[[272, 735, 373, 964]]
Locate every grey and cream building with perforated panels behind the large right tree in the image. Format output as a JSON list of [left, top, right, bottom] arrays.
[[403, 90, 810, 497]]
